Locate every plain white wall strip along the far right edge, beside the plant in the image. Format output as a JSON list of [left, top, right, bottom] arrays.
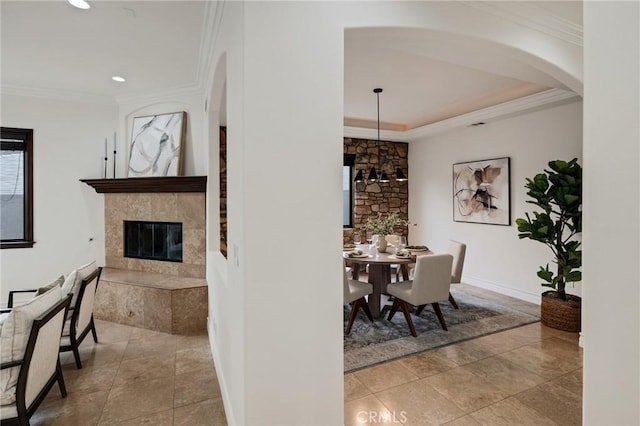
[[582, 2, 640, 425]]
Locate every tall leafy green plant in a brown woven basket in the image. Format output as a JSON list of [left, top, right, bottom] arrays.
[[516, 158, 582, 331]]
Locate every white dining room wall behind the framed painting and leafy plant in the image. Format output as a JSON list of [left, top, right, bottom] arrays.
[[409, 102, 582, 303]]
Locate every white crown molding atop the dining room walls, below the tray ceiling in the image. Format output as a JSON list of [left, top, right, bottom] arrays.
[[344, 89, 582, 142]]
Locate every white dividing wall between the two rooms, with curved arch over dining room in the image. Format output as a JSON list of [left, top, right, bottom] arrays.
[[206, 2, 581, 425]]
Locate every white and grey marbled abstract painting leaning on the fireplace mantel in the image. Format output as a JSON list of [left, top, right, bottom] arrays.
[[128, 111, 187, 177]]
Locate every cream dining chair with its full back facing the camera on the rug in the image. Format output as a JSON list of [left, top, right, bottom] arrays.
[[387, 253, 453, 337]]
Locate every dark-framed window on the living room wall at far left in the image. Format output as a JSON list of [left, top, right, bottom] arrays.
[[0, 127, 34, 249]]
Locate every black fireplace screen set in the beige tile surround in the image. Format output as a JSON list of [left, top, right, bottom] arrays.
[[124, 220, 182, 262]]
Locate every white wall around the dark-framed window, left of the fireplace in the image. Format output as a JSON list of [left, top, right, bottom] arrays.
[[0, 95, 117, 304]]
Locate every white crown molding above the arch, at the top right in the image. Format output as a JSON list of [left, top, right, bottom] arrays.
[[461, 1, 584, 46]]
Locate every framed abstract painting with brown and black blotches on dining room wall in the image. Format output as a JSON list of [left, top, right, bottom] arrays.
[[453, 157, 511, 226]]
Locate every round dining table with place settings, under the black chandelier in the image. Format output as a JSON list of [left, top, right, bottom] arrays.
[[345, 244, 431, 319]]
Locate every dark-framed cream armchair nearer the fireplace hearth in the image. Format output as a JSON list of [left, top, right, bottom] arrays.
[[60, 264, 102, 369]]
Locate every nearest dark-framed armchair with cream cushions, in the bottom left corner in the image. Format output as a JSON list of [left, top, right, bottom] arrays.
[[0, 287, 71, 426]]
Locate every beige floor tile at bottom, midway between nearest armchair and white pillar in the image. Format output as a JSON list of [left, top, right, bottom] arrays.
[[100, 377, 174, 425]]
